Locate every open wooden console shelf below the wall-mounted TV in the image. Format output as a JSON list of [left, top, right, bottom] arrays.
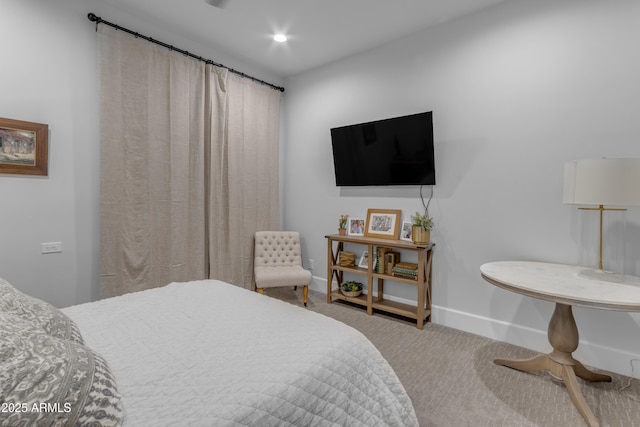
[[325, 234, 435, 329]]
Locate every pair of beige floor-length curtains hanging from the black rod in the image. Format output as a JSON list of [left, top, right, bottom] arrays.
[[98, 26, 280, 297]]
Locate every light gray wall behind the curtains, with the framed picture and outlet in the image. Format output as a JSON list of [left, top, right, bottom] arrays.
[[0, 0, 283, 306]]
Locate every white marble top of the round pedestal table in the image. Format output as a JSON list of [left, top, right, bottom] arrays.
[[480, 261, 640, 311]]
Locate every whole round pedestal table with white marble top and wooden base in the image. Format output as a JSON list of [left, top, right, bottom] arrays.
[[480, 261, 640, 427]]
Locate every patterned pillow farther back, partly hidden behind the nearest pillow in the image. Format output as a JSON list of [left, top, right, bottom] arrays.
[[0, 278, 84, 344]]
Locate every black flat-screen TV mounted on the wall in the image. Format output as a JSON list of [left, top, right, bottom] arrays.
[[331, 111, 436, 187]]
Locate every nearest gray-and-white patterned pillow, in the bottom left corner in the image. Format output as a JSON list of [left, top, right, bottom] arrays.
[[0, 313, 123, 426]]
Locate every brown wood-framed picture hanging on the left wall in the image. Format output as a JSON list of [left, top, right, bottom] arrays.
[[0, 117, 49, 176]]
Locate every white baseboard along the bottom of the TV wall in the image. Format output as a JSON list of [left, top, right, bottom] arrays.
[[310, 277, 640, 378]]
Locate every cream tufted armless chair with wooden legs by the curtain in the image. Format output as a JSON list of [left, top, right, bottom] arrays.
[[253, 231, 311, 306]]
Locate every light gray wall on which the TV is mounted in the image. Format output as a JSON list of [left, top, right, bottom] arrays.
[[284, 0, 640, 373]]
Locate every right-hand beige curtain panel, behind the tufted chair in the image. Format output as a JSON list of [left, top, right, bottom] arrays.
[[209, 73, 281, 288]]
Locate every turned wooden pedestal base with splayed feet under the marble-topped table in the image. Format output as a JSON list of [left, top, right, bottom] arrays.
[[494, 303, 611, 427]]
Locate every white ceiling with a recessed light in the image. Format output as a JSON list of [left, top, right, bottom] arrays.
[[97, 0, 505, 77]]
